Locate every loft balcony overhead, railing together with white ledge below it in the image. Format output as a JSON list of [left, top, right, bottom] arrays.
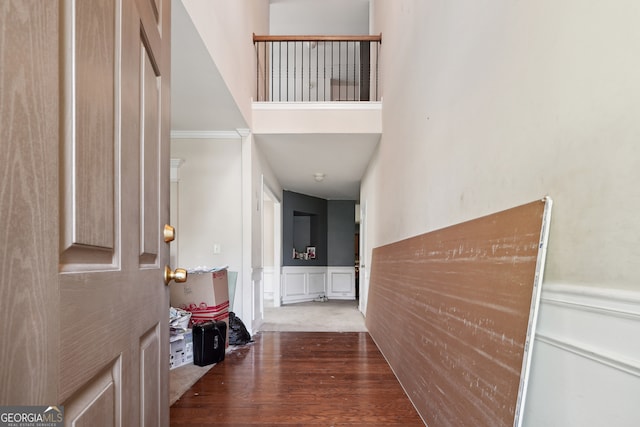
[[253, 34, 382, 134]]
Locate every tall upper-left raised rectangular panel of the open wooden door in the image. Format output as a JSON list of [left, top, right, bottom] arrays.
[[61, 0, 120, 264]]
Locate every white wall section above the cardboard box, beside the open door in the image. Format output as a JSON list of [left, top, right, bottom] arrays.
[[171, 138, 242, 302]]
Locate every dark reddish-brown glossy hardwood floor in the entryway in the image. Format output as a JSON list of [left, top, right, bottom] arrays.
[[171, 332, 424, 427]]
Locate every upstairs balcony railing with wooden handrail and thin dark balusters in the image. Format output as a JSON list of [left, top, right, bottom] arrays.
[[253, 34, 382, 102]]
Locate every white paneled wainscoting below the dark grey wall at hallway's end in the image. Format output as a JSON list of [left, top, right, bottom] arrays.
[[282, 267, 356, 304]]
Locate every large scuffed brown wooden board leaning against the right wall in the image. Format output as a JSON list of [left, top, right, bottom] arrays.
[[366, 201, 545, 426]]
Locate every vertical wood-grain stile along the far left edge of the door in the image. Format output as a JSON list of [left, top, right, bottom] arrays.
[[0, 0, 59, 405]]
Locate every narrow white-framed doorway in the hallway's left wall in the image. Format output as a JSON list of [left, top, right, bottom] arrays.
[[262, 181, 282, 307]]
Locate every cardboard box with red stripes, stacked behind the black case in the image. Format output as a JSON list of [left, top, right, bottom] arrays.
[[170, 268, 229, 343]]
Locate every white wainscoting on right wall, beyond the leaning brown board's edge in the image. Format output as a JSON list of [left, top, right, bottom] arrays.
[[523, 284, 640, 427]]
